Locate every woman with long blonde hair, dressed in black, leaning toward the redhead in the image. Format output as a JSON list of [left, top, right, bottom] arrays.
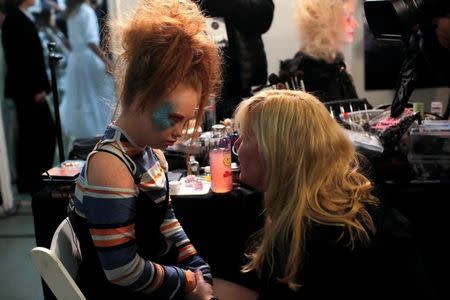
[[214, 90, 434, 300]]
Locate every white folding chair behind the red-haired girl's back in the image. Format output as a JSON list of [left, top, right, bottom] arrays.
[[31, 218, 86, 300]]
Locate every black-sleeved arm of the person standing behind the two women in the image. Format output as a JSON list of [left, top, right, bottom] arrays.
[[198, 0, 274, 34]]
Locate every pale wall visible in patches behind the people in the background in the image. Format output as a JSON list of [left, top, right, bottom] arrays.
[[108, 0, 449, 110]]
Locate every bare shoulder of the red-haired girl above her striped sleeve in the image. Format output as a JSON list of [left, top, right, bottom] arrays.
[[87, 152, 135, 189]]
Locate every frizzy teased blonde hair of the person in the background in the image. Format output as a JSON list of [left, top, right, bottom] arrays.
[[295, 0, 356, 62]]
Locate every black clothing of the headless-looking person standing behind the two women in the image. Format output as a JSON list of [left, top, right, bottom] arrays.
[[197, 0, 274, 119]]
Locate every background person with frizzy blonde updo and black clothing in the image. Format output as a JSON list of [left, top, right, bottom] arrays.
[[280, 0, 358, 102]]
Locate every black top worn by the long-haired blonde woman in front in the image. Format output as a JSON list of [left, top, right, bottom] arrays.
[[259, 205, 436, 300]]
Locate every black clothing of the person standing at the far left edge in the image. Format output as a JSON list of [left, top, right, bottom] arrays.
[[2, 8, 56, 193]]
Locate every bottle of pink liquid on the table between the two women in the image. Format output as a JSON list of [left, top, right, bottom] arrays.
[[209, 124, 233, 193]]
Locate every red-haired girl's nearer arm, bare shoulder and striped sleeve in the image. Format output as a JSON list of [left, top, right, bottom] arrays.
[[84, 152, 195, 299]]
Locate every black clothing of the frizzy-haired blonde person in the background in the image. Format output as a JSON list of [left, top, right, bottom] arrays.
[[280, 51, 358, 102]]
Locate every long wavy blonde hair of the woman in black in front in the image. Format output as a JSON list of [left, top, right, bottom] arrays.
[[235, 90, 378, 290]]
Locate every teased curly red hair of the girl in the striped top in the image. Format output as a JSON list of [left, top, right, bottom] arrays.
[[113, 0, 221, 121]]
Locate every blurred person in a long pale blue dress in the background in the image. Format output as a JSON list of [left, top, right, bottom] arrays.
[[61, 0, 115, 138]]
